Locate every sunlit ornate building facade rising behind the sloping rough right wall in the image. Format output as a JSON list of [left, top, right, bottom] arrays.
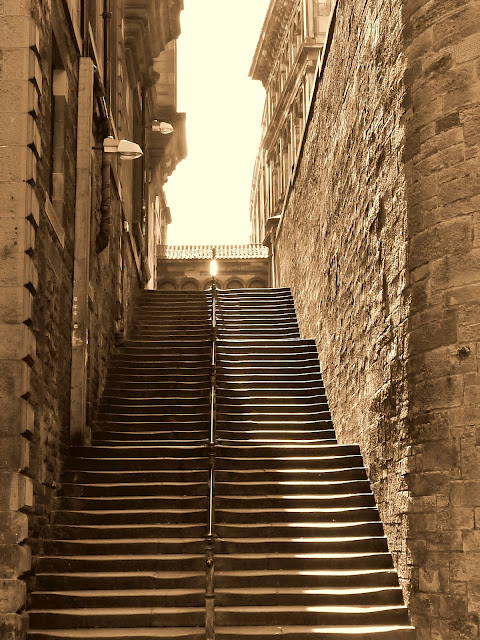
[[250, 0, 331, 248]]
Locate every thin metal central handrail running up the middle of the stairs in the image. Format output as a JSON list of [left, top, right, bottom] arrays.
[[205, 277, 217, 640]]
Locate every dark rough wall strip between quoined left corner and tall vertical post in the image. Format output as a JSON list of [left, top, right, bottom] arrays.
[[29, 3, 78, 553]]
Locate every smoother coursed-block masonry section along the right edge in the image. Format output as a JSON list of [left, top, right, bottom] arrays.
[[403, 0, 480, 640]]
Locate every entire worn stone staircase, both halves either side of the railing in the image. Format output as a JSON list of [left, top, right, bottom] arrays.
[[28, 289, 415, 640]]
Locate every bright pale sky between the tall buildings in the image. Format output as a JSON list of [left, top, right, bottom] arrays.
[[165, 0, 269, 244]]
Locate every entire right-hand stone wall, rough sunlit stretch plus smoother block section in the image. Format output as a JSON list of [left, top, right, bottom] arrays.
[[276, 0, 480, 640]]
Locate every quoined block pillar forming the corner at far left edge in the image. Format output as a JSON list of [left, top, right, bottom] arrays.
[[0, 2, 42, 640]]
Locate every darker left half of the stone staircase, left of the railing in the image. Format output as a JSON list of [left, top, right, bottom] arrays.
[[28, 291, 211, 640]]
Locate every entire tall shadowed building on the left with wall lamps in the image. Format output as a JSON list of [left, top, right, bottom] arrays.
[[0, 0, 186, 640]]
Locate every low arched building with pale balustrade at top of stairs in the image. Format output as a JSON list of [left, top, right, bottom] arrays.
[[156, 244, 270, 291]]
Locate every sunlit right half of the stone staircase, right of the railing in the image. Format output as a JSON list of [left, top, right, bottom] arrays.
[[215, 289, 415, 640]]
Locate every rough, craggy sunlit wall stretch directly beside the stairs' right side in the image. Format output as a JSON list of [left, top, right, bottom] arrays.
[[276, 0, 408, 578]]
